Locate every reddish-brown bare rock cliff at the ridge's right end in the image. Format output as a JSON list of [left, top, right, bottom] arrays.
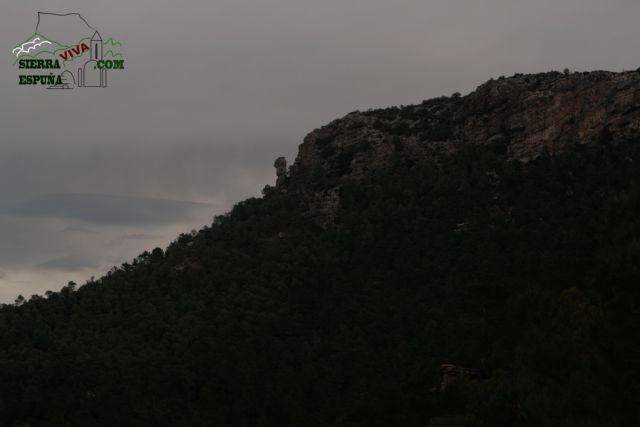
[[459, 72, 640, 161]]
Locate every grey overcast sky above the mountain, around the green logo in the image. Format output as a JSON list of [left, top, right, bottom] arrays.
[[0, 0, 640, 302]]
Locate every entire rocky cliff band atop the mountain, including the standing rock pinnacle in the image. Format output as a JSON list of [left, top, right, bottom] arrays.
[[276, 71, 640, 224]]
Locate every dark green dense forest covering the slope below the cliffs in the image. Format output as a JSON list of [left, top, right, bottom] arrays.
[[0, 79, 640, 427]]
